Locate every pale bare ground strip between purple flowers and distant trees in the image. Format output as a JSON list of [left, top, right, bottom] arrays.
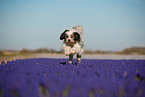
[[0, 53, 145, 63]]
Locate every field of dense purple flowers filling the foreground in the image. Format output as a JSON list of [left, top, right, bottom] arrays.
[[0, 58, 145, 97]]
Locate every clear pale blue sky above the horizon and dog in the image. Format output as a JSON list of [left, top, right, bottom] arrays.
[[0, 0, 145, 51]]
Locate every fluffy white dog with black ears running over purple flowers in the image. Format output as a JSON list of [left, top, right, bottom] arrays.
[[60, 25, 84, 64]]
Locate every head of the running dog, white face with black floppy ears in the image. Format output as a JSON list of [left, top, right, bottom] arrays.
[[60, 29, 81, 45]]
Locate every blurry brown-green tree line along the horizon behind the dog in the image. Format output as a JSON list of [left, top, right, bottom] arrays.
[[0, 47, 145, 55]]
